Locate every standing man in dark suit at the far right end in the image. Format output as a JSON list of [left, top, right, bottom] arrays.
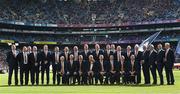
[[164, 43, 175, 85]]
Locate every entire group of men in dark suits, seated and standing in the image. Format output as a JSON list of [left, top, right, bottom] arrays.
[[7, 43, 175, 85]]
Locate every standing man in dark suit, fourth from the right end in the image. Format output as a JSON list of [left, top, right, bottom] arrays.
[[142, 45, 150, 85]]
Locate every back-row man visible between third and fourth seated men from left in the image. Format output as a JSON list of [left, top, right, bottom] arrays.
[[81, 44, 91, 62]]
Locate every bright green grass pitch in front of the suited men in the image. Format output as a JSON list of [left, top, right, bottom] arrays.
[[0, 70, 180, 94]]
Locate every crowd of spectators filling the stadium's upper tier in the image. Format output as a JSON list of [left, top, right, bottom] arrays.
[[0, 0, 180, 24]]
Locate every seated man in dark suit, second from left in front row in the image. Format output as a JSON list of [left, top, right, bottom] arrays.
[[67, 54, 79, 84]]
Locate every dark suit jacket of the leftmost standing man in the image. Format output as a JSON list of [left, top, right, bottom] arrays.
[[6, 51, 18, 67]]
